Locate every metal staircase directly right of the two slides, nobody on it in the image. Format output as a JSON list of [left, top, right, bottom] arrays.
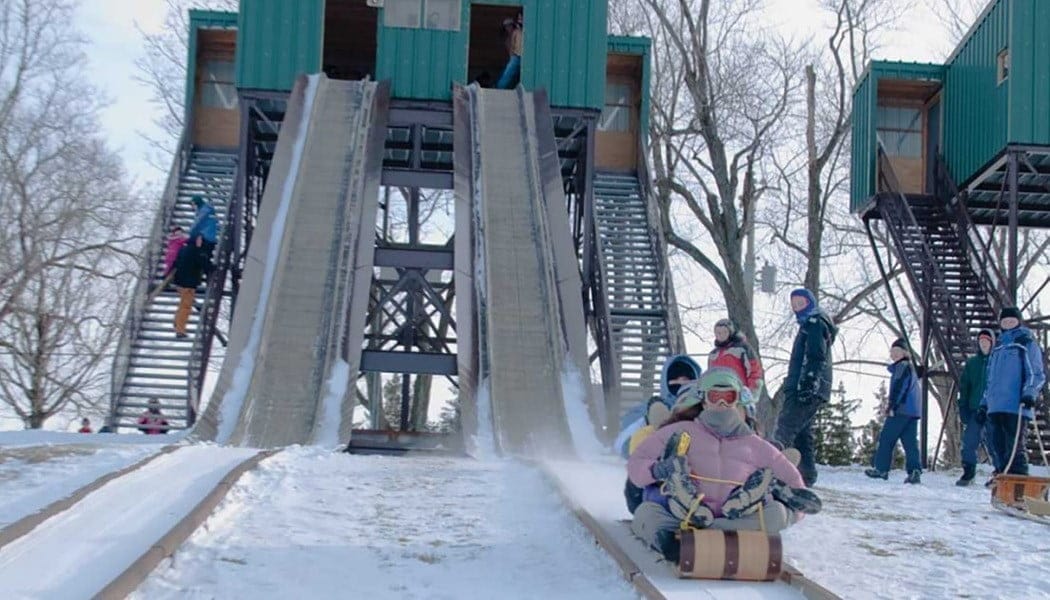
[[592, 172, 684, 418]]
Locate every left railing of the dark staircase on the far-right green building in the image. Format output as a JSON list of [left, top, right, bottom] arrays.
[[878, 144, 970, 381]]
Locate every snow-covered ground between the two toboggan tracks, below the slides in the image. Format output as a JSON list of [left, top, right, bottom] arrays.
[[135, 448, 637, 600]]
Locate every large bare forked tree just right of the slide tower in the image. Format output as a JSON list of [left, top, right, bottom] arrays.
[[643, 0, 801, 361]]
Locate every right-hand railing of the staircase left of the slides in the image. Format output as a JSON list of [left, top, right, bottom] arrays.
[[186, 154, 240, 427]]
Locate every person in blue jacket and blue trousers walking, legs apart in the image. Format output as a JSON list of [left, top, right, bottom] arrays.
[[864, 338, 922, 483]]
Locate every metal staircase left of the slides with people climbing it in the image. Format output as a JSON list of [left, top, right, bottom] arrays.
[[108, 150, 236, 431]]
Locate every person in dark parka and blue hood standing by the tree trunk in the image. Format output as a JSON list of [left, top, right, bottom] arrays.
[[773, 288, 838, 487]]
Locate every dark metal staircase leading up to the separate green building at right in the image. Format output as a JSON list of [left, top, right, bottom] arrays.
[[865, 148, 1050, 462]]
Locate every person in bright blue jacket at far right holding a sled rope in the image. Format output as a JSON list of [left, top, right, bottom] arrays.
[[978, 307, 1046, 475]]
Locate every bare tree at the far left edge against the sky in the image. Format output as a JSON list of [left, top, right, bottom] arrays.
[[0, 0, 139, 427]]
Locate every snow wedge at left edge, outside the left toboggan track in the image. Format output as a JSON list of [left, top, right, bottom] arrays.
[[0, 434, 159, 527]]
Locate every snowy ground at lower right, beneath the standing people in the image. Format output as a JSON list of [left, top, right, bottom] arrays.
[[783, 468, 1050, 600]]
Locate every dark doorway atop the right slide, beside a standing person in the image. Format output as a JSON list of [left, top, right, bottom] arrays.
[[466, 4, 524, 87]]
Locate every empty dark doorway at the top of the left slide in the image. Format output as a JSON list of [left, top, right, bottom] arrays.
[[322, 0, 379, 81]]
